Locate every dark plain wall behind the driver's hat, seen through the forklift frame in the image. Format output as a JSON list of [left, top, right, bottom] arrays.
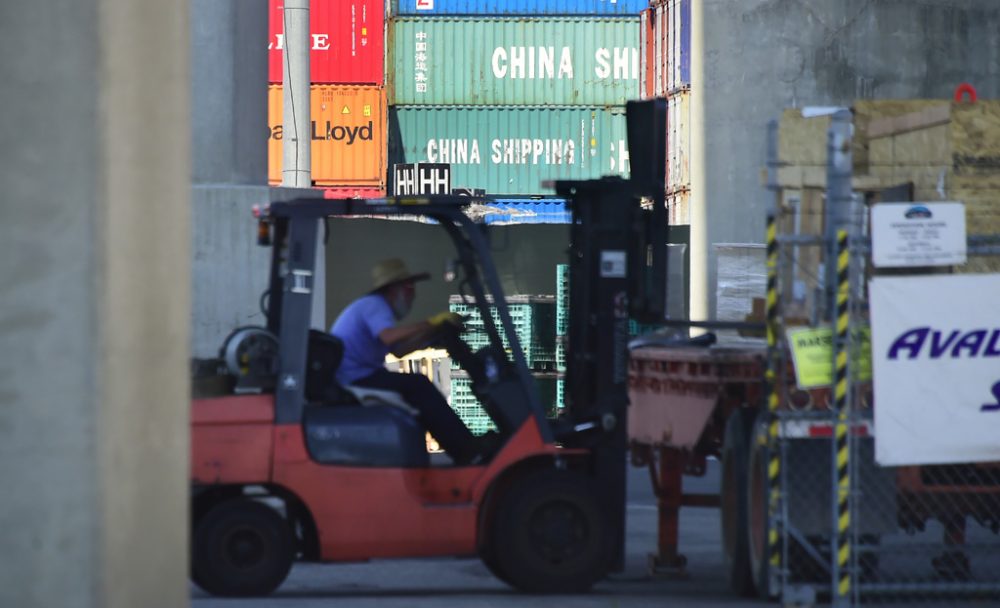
[[326, 220, 569, 326]]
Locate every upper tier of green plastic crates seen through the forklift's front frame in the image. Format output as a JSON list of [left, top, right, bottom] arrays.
[[448, 296, 556, 371]]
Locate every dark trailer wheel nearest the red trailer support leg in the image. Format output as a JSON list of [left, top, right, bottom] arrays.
[[719, 407, 756, 597]]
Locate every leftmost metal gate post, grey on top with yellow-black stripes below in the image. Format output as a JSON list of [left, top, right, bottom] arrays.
[[764, 120, 785, 595]]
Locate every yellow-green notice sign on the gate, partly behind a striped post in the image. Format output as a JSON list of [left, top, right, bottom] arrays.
[[786, 326, 872, 389]]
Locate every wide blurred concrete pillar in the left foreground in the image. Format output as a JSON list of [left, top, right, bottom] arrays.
[[0, 0, 190, 608]]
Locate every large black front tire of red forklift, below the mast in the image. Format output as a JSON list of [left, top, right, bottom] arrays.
[[487, 471, 611, 593]]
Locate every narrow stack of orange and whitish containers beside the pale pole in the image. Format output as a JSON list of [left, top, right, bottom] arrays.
[[640, 0, 691, 225]]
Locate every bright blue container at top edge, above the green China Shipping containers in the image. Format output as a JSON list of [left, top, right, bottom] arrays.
[[391, 0, 649, 15]]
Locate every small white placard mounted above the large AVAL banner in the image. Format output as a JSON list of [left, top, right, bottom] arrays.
[[871, 202, 966, 268]]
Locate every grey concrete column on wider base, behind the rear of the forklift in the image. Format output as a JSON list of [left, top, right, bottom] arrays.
[[190, 0, 324, 357]]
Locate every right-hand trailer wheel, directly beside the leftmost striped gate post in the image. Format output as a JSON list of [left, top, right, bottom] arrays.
[[747, 416, 777, 599]]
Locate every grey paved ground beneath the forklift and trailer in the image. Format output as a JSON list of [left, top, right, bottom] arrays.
[[191, 466, 762, 608]]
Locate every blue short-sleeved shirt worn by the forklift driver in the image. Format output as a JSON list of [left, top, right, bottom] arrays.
[[330, 294, 396, 384]]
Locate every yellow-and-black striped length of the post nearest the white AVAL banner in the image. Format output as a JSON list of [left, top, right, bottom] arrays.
[[833, 230, 851, 598]]
